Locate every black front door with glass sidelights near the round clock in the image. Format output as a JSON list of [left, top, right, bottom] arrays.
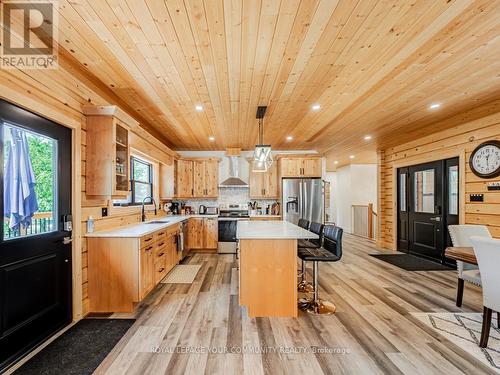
[[397, 158, 459, 262]]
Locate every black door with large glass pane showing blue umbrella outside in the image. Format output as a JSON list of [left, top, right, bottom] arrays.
[[0, 100, 72, 371]]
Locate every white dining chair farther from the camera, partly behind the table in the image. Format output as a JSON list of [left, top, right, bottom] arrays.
[[448, 224, 491, 307]]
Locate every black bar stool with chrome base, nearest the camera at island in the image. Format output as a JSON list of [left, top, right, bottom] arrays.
[[298, 225, 343, 314]]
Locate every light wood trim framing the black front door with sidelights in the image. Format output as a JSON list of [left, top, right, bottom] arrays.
[[388, 149, 467, 251]]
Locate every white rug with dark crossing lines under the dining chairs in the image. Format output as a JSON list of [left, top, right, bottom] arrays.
[[412, 313, 500, 374]]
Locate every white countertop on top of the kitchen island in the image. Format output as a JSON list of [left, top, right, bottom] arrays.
[[236, 221, 319, 240]]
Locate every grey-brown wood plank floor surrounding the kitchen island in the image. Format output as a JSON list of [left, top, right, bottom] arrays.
[[96, 235, 494, 375]]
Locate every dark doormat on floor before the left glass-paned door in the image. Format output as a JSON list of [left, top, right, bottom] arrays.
[[14, 319, 135, 375]]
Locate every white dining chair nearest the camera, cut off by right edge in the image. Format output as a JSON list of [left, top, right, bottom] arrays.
[[470, 236, 500, 348]]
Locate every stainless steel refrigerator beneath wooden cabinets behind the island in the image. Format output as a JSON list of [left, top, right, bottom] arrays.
[[281, 178, 325, 224]]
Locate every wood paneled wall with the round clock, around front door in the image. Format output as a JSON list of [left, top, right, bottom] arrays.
[[378, 108, 500, 250]]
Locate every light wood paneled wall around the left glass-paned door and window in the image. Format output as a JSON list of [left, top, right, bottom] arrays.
[[0, 68, 176, 319]]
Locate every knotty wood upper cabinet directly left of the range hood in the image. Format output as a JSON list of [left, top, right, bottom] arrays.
[[175, 159, 219, 198]]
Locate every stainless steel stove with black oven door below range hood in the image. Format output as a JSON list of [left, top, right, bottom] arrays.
[[217, 203, 250, 254]]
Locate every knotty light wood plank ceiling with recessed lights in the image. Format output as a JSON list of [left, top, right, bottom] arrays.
[[51, 0, 500, 158]]
